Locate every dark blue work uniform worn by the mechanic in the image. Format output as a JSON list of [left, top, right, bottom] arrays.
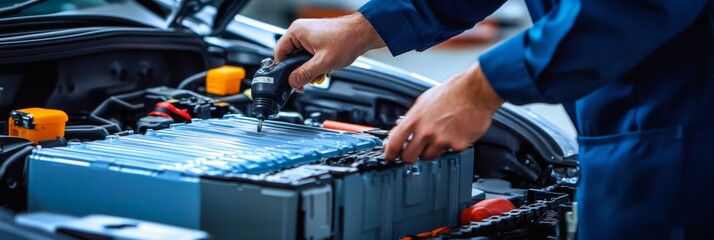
[[360, 0, 714, 239]]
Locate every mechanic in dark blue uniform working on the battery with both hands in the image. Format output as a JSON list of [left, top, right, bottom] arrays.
[[275, 0, 714, 239]]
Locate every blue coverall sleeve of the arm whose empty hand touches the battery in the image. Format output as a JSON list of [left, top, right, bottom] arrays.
[[479, 0, 707, 104]]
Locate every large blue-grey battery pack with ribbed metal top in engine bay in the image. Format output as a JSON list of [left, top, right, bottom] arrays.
[[28, 115, 473, 239]]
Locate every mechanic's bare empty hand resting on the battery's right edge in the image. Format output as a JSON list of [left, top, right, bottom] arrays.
[[384, 64, 504, 164]]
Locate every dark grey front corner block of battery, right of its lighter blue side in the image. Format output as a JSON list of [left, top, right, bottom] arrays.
[[201, 177, 333, 239]]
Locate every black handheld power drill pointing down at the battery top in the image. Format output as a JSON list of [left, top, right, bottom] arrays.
[[251, 50, 312, 132]]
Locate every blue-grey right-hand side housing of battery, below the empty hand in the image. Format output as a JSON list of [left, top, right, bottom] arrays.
[[333, 149, 474, 239]]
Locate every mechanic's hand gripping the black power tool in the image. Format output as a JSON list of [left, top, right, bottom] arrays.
[[275, 12, 386, 92]]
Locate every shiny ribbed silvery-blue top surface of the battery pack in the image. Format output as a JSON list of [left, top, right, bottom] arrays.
[[30, 115, 381, 175]]
